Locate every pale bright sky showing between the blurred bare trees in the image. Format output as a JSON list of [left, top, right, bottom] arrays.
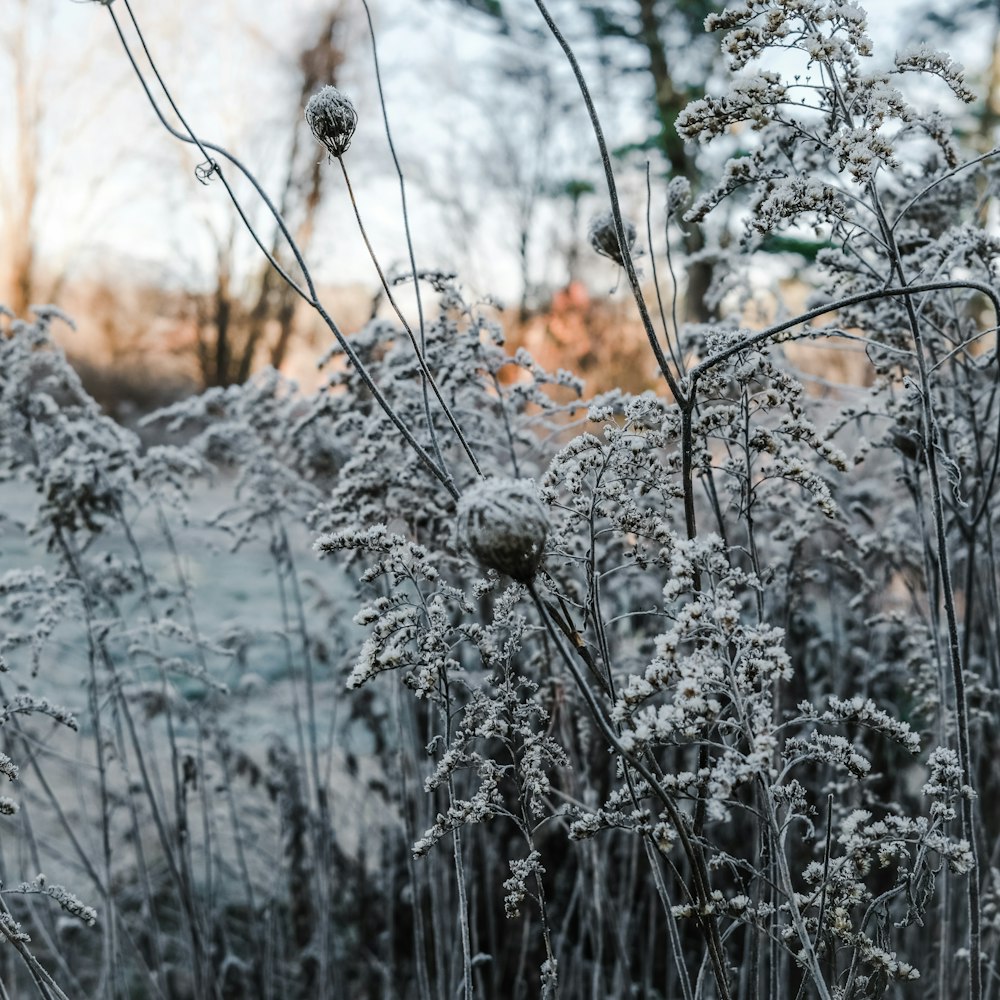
[[0, 0, 989, 312]]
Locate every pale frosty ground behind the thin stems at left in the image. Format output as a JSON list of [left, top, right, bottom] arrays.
[[0, 483, 388, 896]]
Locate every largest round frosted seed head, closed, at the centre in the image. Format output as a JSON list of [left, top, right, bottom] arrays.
[[458, 479, 549, 583]]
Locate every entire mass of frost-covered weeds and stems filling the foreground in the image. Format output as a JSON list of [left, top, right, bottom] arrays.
[[23, 0, 1000, 1000]]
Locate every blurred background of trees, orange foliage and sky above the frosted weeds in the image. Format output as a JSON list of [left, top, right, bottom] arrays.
[[0, 0, 1000, 410]]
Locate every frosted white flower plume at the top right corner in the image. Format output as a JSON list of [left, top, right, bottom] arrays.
[[677, 0, 972, 244]]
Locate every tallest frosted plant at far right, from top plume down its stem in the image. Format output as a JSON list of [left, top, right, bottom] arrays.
[[678, 3, 998, 996]]
